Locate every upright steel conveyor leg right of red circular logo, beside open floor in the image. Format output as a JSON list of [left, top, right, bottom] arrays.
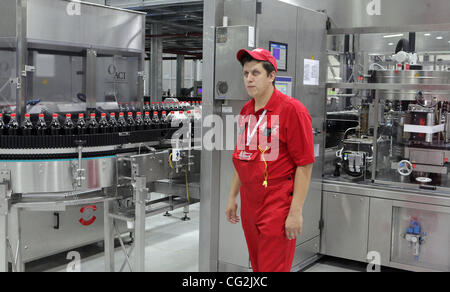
[[134, 176, 148, 272]]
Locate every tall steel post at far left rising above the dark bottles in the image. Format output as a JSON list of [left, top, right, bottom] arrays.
[[16, 0, 28, 124]]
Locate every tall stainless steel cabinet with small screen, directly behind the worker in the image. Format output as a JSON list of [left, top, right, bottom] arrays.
[[200, 0, 327, 271]]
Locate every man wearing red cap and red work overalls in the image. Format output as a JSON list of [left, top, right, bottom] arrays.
[[226, 48, 314, 272]]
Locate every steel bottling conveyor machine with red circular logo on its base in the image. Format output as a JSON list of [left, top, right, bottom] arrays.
[[0, 0, 201, 271]]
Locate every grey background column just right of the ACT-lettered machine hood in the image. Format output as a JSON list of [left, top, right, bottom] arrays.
[[150, 23, 163, 101]]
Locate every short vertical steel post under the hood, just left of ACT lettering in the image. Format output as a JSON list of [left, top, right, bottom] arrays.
[[84, 49, 97, 109]]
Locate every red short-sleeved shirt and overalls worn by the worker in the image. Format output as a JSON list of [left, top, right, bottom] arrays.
[[233, 89, 314, 272]]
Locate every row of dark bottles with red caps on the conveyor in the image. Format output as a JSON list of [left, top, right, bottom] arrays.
[[0, 111, 190, 136]]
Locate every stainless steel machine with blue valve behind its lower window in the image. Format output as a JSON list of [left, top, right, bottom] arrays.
[[321, 12, 450, 271]]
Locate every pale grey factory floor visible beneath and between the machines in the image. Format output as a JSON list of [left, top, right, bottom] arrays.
[[26, 203, 404, 272]]
